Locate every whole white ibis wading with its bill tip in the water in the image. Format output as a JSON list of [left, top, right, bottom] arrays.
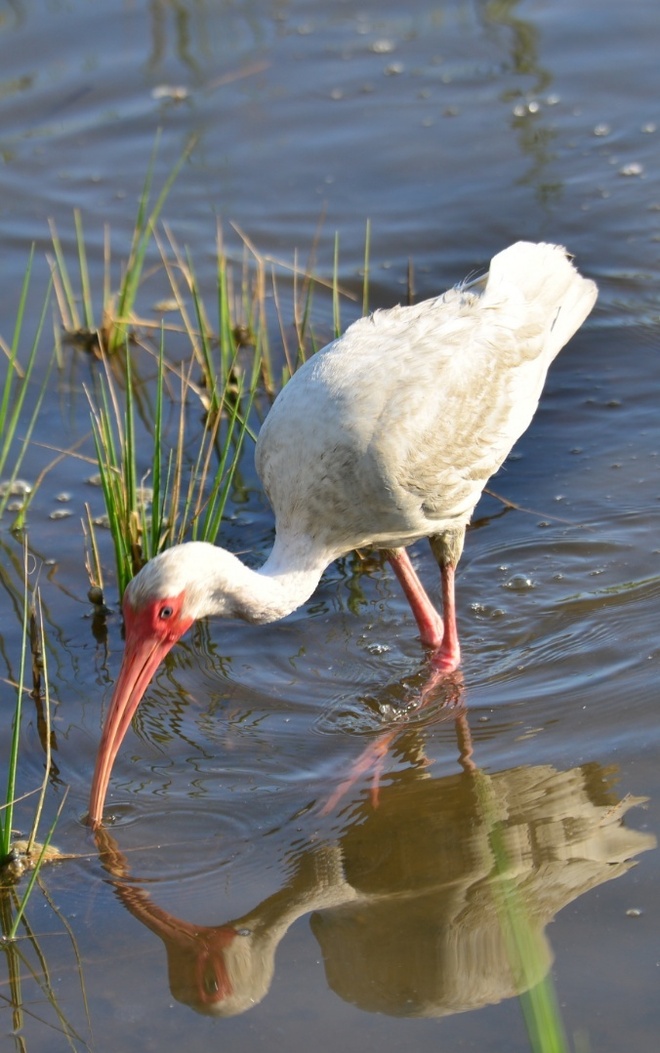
[[89, 241, 597, 824]]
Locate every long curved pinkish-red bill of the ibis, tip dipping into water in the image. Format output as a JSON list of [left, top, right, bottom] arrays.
[[89, 636, 175, 827]]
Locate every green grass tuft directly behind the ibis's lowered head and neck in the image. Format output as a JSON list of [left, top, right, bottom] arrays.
[[87, 324, 259, 594]]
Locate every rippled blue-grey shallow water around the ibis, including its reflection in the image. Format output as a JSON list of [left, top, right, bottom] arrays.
[[0, 0, 660, 1053]]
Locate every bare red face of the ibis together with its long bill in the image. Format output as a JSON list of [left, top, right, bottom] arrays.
[[89, 593, 194, 827]]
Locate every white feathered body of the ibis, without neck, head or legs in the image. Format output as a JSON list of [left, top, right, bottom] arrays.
[[256, 242, 596, 561]]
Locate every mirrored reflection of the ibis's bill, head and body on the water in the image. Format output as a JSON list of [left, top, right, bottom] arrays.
[[97, 764, 656, 1016]]
